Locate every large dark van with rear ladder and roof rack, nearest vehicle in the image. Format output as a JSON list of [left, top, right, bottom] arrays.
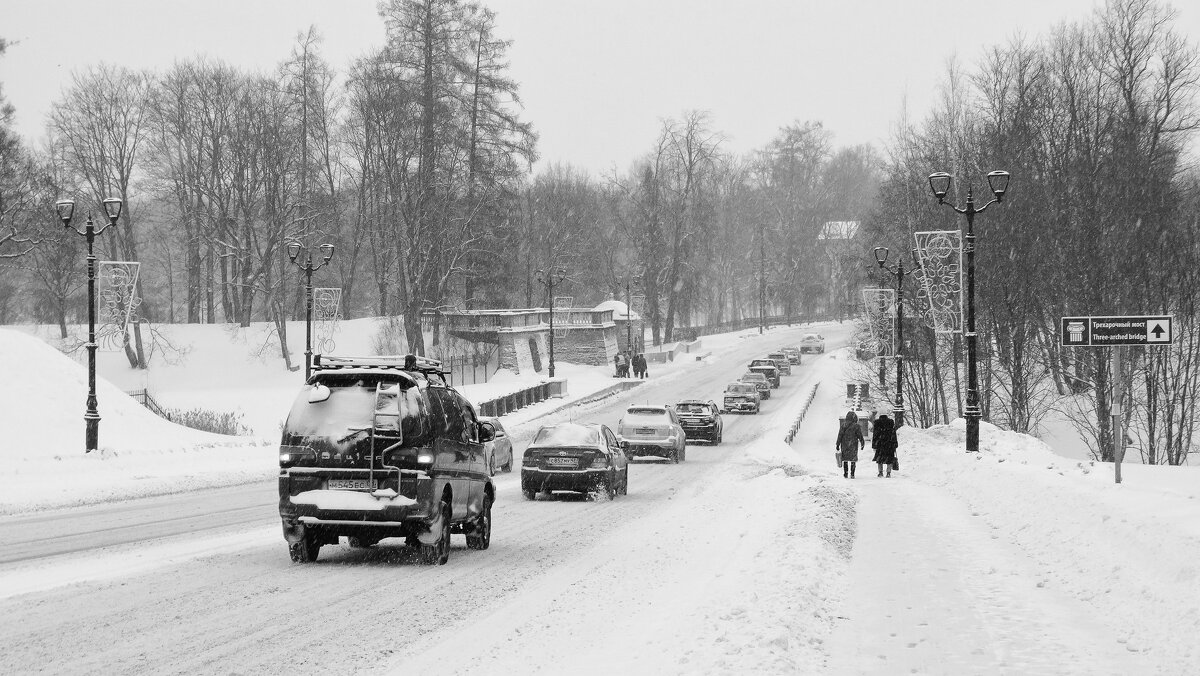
[[278, 354, 496, 564]]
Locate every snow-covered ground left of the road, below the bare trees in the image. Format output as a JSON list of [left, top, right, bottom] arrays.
[[0, 319, 728, 514]]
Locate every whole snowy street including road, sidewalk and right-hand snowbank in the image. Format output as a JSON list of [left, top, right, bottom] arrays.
[[0, 324, 1200, 674]]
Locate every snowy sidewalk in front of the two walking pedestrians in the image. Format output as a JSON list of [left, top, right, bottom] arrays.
[[829, 477, 1138, 675]]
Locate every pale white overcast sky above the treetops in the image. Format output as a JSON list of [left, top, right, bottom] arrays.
[[7, 0, 1200, 175]]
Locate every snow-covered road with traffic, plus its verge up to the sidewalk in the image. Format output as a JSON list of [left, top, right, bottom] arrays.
[[0, 329, 852, 674]]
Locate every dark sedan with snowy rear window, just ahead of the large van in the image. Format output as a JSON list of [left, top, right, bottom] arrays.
[[521, 423, 629, 499]]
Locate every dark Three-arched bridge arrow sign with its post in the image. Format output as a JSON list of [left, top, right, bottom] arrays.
[[1058, 315, 1175, 484]]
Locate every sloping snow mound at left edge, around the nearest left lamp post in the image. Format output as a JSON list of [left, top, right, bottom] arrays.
[[0, 329, 277, 514]]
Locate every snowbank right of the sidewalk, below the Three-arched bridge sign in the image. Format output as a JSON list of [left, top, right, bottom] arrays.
[[900, 419, 1200, 674]]
